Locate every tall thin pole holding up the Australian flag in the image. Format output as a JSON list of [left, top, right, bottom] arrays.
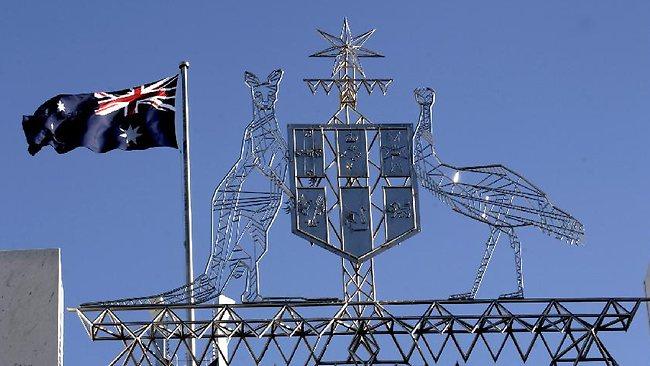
[[178, 61, 196, 366]]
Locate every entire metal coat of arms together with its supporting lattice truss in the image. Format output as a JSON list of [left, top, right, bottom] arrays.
[[70, 19, 636, 366]]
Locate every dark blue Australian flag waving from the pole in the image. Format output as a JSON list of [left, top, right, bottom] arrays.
[[23, 75, 178, 155]]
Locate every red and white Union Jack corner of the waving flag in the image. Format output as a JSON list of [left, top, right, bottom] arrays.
[[94, 75, 178, 116]]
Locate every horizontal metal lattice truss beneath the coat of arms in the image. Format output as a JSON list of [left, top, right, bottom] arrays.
[[76, 298, 650, 366]]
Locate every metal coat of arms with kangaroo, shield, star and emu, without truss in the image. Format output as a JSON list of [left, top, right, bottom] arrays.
[[81, 19, 584, 304]]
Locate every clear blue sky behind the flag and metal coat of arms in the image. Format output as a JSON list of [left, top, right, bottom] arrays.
[[0, 0, 650, 365]]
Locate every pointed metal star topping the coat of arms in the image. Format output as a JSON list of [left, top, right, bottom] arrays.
[[309, 18, 384, 77]]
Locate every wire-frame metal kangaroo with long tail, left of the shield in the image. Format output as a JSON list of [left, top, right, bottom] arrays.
[[83, 70, 291, 306]]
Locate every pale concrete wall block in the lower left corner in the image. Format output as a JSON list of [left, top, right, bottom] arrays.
[[0, 249, 63, 366]]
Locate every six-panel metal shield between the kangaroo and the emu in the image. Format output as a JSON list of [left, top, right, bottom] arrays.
[[288, 124, 420, 263]]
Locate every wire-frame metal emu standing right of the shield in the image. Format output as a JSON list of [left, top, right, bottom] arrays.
[[414, 88, 584, 299]]
